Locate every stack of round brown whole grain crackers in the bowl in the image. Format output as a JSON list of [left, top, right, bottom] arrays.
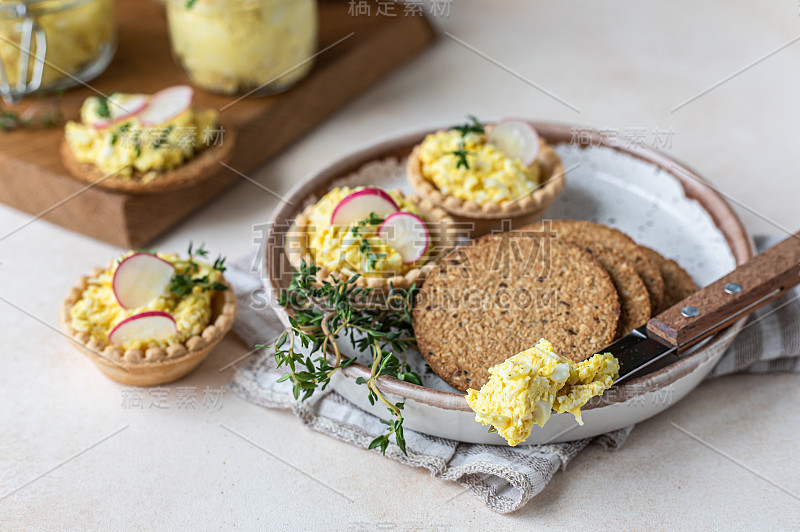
[[413, 220, 696, 392]]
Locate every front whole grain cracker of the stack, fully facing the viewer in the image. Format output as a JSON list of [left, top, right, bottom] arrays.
[[413, 233, 620, 391]]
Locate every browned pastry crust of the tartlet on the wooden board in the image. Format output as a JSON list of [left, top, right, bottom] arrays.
[[60, 120, 236, 194]]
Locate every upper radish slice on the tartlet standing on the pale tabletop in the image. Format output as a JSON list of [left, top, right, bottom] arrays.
[[111, 253, 175, 308]]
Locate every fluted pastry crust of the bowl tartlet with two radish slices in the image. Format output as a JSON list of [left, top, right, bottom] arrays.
[[284, 190, 458, 292]]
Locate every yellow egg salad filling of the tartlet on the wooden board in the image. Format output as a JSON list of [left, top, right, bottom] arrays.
[[65, 93, 219, 178]]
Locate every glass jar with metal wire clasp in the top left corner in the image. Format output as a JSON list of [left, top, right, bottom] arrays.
[[0, 0, 116, 103]]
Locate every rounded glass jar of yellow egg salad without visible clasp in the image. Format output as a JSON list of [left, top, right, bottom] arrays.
[[167, 0, 317, 95]]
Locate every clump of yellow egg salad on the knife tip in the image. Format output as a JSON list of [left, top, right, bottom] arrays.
[[467, 338, 619, 446]]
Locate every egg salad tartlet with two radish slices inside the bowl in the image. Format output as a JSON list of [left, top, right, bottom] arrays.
[[285, 186, 456, 288]]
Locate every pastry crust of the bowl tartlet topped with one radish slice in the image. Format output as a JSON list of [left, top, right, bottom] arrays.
[[406, 134, 566, 238]]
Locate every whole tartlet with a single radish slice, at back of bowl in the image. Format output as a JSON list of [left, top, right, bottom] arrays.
[[407, 117, 565, 237]]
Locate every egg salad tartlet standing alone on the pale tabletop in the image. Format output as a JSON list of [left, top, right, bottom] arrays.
[[60, 246, 236, 386]]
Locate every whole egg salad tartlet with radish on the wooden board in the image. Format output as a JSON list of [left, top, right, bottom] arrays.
[[61, 85, 233, 193]]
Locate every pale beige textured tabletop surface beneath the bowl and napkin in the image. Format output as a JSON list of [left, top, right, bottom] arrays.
[[0, 0, 800, 530]]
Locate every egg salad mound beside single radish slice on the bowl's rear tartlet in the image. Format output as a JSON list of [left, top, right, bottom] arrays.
[[419, 129, 541, 205]]
